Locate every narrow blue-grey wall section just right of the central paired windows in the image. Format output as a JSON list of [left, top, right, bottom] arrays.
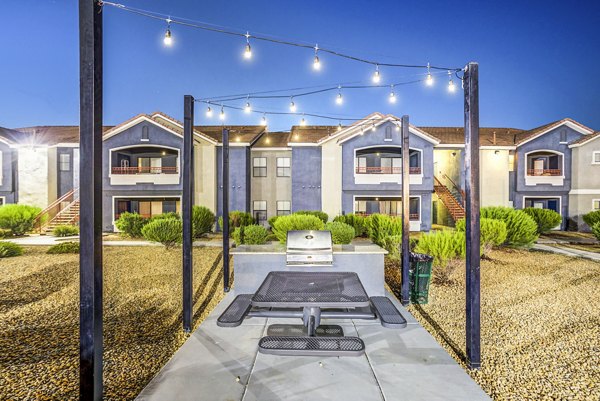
[[292, 146, 322, 212]]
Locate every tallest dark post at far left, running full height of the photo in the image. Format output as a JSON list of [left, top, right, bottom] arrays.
[[79, 0, 103, 401]]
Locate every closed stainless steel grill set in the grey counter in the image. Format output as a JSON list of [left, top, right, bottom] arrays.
[[286, 230, 333, 266]]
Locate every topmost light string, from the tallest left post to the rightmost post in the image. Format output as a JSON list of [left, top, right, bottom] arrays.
[[99, 0, 462, 72]]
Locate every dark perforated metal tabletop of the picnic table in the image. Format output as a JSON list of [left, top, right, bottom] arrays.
[[252, 271, 369, 308]]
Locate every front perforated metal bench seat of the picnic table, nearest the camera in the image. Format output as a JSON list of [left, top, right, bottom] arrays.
[[258, 336, 365, 356]]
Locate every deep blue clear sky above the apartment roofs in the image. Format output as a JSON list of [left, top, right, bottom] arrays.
[[0, 0, 600, 130]]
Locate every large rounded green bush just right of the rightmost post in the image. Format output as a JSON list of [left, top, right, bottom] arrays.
[[481, 206, 538, 246]]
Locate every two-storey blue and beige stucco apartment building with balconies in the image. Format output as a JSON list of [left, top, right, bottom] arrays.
[[0, 112, 600, 231]]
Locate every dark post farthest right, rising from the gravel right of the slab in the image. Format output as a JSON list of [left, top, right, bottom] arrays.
[[464, 63, 481, 369]]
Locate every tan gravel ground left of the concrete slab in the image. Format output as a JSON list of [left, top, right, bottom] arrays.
[[0, 247, 223, 400]]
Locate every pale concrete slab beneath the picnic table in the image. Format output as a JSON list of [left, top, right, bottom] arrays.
[[137, 293, 490, 401]]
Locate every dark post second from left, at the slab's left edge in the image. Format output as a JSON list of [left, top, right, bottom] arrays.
[[181, 95, 194, 332]]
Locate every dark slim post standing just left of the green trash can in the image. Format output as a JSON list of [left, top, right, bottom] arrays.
[[400, 116, 410, 306]]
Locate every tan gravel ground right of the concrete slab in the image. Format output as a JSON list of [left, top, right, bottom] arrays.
[[386, 249, 600, 401]]
